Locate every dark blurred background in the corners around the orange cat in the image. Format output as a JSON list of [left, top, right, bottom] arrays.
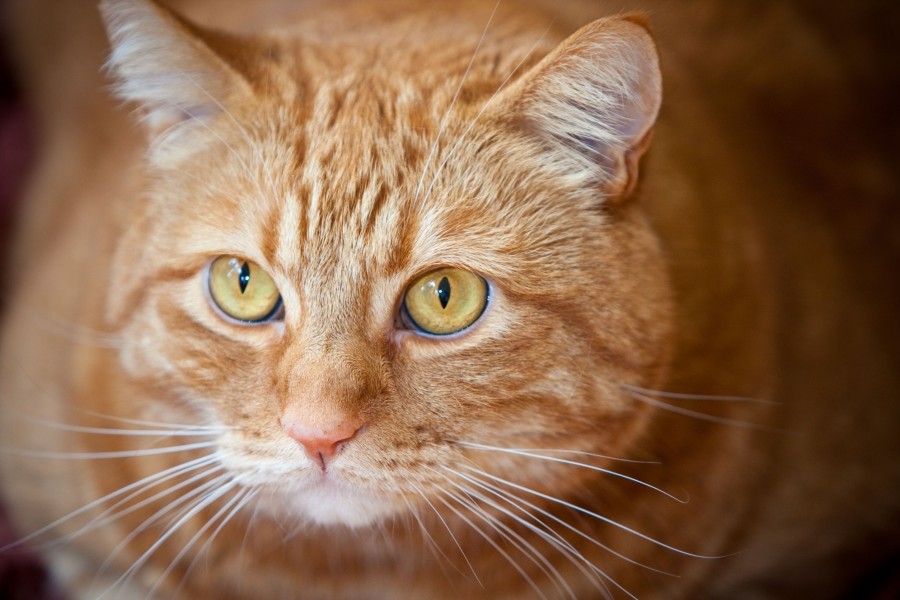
[[0, 0, 900, 600]]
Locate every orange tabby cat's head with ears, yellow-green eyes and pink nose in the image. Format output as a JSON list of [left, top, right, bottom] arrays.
[[102, 0, 672, 525]]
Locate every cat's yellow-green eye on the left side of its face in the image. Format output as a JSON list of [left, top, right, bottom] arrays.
[[209, 256, 281, 323]]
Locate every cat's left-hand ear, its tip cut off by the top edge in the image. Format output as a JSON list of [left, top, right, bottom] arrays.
[[100, 0, 250, 136]]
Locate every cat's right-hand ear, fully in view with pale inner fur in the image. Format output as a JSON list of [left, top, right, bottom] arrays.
[[506, 16, 662, 200]]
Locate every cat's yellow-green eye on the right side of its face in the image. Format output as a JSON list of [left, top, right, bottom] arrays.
[[403, 267, 488, 335]]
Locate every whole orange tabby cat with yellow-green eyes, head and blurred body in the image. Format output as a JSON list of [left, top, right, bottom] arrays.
[[0, 0, 900, 599]]
